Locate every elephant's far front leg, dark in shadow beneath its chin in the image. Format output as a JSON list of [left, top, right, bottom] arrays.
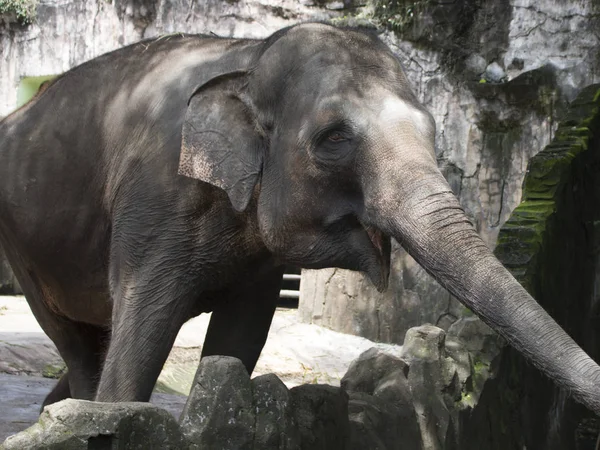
[[202, 267, 284, 374]]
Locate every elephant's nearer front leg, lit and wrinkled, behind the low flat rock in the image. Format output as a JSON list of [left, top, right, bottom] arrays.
[[96, 232, 200, 402]]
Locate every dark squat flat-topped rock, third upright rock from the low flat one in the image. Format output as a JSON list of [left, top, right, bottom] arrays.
[[290, 384, 350, 450]]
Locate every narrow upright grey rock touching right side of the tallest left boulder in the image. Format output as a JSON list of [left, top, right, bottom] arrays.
[[252, 374, 300, 450]]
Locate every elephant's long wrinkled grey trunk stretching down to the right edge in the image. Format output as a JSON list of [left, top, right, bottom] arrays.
[[365, 162, 600, 415]]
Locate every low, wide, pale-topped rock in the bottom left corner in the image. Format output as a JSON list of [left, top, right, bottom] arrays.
[[0, 399, 187, 450]]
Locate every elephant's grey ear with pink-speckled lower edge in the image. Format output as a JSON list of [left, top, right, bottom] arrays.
[[179, 73, 264, 212]]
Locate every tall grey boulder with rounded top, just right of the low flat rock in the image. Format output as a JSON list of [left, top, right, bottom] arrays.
[[180, 356, 255, 450]]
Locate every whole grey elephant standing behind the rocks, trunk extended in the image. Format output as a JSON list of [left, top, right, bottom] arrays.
[[0, 24, 600, 413]]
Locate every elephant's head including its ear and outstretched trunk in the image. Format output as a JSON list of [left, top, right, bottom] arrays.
[[180, 24, 600, 413]]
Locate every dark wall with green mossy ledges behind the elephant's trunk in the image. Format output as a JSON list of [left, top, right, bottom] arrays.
[[460, 84, 600, 450]]
